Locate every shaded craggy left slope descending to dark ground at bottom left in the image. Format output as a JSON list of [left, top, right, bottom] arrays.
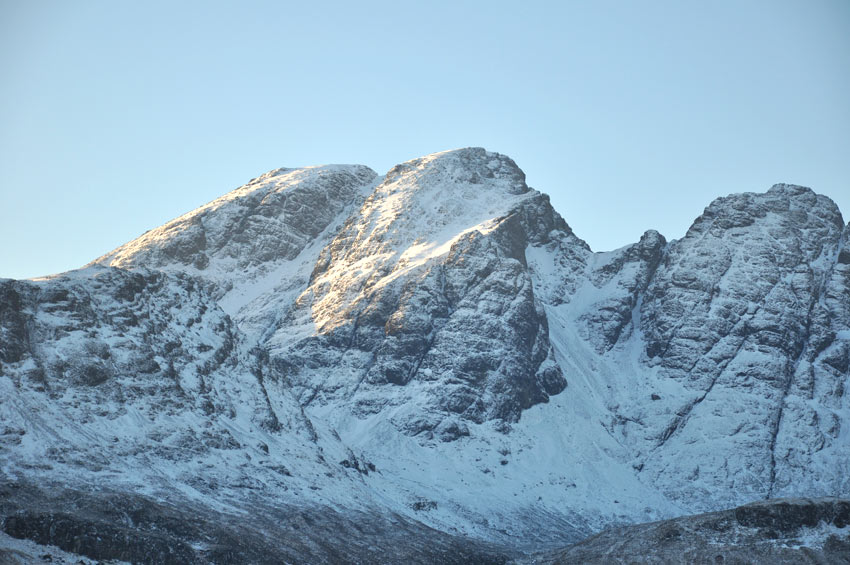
[[0, 266, 504, 563]]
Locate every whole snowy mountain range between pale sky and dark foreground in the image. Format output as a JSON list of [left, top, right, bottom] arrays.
[[0, 148, 850, 559]]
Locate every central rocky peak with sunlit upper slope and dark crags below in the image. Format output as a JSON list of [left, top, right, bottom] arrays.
[[267, 149, 564, 439]]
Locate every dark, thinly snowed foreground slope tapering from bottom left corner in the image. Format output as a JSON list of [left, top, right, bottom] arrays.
[[0, 483, 516, 565]]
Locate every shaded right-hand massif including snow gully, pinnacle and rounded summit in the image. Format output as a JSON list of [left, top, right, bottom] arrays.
[[528, 185, 850, 509]]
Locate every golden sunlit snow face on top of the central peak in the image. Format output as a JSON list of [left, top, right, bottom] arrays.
[[284, 149, 531, 333]]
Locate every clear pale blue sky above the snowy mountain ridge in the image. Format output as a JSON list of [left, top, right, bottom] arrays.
[[0, 0, 850, 278]]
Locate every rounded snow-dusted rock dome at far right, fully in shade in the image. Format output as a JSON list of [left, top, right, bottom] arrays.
[[641, 185, 850, 506]]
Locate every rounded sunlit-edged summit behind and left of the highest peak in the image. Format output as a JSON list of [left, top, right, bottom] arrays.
[[90, 165, 377, 271]]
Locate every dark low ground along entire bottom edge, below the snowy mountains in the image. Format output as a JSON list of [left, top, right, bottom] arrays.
[[0, 481, 850, 565]]
